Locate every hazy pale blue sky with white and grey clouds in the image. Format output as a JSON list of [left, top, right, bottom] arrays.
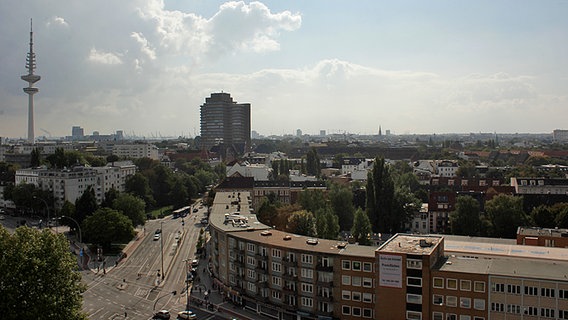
[[0, 0, 568, 138]]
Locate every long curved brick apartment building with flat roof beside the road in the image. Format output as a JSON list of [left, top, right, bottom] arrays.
[[210, 192, 568, 320]]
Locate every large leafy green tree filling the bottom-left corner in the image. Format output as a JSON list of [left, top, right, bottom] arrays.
[[0, 226, 87, 320]]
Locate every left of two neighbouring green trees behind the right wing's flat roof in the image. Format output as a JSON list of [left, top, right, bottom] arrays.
[[450, 196, 481, 236]]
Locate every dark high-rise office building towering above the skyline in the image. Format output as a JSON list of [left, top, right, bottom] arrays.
[[201, 92, 250, 153]]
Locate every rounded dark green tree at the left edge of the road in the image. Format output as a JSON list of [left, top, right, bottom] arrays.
[[81, 208, 134, 250]]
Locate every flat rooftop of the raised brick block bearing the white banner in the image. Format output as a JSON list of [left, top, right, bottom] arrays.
[[377, 233, 443, 255]]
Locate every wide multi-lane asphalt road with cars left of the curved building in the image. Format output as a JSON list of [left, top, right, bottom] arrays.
[[83, 204, 222, 320]]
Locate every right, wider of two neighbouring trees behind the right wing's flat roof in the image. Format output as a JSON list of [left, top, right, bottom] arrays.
[[485, 194, 530, 239]]
